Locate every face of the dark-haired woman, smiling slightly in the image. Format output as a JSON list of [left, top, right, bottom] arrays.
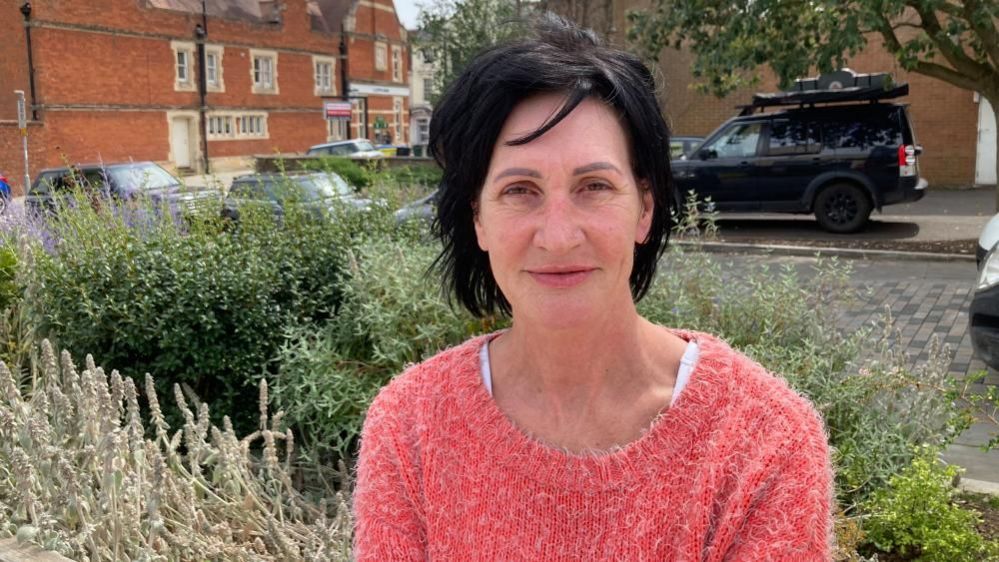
[[475, 94, 652, 328]]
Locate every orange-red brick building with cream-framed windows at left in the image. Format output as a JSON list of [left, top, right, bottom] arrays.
[[0, 0, 408, 189]]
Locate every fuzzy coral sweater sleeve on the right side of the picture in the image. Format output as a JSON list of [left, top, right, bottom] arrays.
[[723, 400, 833, 562]]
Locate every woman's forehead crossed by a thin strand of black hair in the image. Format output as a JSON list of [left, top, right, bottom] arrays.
[[493, 94, 629, 162]]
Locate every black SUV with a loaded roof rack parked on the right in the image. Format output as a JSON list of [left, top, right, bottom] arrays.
[[672, 71, 927, 233]]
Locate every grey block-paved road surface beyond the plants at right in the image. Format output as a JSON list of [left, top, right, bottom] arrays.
[[718, 255, 999, 484]]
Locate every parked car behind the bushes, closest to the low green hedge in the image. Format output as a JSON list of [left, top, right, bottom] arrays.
[[222, 172, 373, 221]]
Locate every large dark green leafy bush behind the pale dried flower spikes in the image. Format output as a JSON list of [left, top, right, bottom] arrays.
[[15, 189, 392, 429]]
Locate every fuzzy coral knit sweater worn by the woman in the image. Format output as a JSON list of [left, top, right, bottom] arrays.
[[354, 330, 832, 561]]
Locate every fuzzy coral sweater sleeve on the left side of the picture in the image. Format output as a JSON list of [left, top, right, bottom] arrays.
[[353, 385, 426, 562]]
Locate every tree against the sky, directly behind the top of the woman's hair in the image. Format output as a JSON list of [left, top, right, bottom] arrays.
[[415, 0, 526, 102]]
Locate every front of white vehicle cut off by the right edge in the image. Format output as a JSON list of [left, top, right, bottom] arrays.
[[968, 210, 999, 369]]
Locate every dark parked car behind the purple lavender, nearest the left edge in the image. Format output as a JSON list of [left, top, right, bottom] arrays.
[[25, 162, 219, 217]]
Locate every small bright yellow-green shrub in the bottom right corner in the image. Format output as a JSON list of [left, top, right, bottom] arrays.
[[864, 447, 999, 562]]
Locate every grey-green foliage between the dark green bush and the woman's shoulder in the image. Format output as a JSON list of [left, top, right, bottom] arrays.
[[272, 239, 494, 459]]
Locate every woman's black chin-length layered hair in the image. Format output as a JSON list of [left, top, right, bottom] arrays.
[[429, 14, 673, 317]]
